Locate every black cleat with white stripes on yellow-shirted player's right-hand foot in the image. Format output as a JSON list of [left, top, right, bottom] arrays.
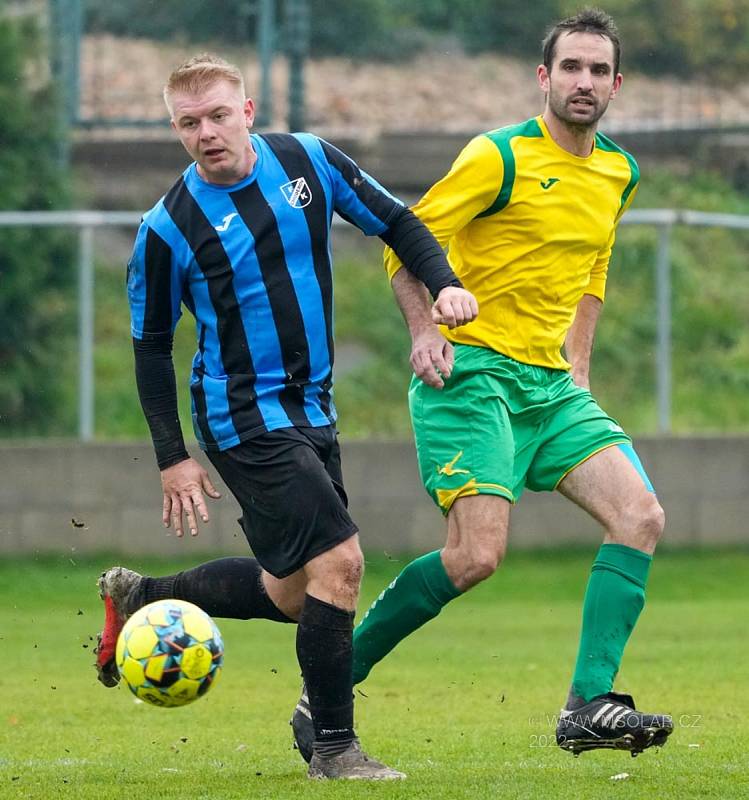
[[557, 692, 674, 757]]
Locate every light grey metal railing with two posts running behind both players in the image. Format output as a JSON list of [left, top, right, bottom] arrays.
[[0, 209, 749, 442]]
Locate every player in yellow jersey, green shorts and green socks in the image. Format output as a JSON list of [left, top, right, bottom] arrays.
[[293, 9, 673, 755]]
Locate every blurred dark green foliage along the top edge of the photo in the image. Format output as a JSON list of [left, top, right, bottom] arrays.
[[87, 0, 749, 79]]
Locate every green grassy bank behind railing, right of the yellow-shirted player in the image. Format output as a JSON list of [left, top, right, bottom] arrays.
[[592, 169, 749, 433]]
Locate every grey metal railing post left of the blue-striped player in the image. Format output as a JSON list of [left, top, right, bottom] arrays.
[[78, 225, 94, 442]]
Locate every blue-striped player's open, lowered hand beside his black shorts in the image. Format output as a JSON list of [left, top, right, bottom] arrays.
[[161, 458, 221, 538]]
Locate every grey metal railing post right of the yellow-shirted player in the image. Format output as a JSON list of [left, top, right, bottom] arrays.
[[655, 224, 671, 433]]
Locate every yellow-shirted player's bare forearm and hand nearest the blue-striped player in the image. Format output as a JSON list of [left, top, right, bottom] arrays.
[[391, 269, 453, 389]]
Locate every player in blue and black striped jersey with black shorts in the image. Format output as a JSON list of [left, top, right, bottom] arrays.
[[96, 55, 477, 779]]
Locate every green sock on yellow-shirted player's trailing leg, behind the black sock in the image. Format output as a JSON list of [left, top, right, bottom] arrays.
[[354, 550, 461, 683]]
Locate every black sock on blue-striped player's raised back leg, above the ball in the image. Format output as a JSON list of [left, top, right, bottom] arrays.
[[140, 558, 296, 622]]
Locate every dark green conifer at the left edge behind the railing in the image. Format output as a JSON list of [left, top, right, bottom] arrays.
[[0, 17, 75, 436]]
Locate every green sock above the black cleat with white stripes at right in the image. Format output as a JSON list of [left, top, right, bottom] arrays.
[[572, 544, 653, 702]]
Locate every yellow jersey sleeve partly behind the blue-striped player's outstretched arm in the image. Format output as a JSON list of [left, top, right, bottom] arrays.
[[384, 135, 504, 280]]
